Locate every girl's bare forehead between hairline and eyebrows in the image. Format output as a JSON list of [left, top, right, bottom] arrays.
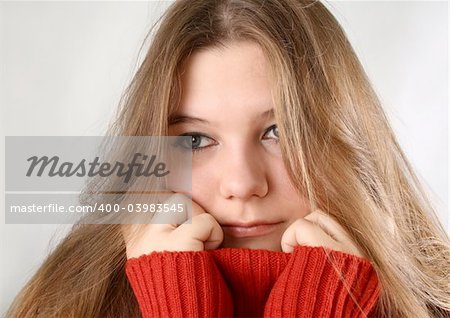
[[179, 42, 272, 120]]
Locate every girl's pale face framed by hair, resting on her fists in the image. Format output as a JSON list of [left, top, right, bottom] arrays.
[[169, 42, 310, 251]]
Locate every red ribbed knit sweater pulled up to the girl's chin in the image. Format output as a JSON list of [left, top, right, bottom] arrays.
[[126, 246, 380, 318]]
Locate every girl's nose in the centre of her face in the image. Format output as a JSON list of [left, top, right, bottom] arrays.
[[219, 149, 268, 200]]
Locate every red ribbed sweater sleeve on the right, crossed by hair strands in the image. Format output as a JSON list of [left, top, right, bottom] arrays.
[[264, 246, 380, 318]]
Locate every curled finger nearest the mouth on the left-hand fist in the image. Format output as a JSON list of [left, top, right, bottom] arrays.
[[175, 213, 223, 250]]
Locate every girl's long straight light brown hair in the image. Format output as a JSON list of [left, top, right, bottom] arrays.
[[8, 0, 450, 317]]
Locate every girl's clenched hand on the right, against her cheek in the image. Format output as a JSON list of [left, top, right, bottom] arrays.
[[281, 210, 364, 257]]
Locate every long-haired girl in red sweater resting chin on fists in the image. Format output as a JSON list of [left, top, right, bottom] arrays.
[[8, 0, 450, 317]]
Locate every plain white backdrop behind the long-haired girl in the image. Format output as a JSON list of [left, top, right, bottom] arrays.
[[0, 1, 450, 314]]
